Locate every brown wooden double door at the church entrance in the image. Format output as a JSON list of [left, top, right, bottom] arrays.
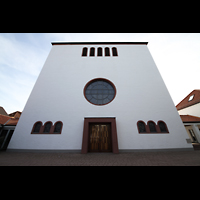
[[89, 123, 112, 152]]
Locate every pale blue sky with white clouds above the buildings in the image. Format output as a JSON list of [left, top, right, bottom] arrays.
[[0, 33, 200, 113]]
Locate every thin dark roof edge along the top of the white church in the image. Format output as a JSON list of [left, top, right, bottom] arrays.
[[51, 42, 148, 45]]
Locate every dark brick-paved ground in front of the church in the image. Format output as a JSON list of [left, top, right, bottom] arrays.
[[0, 150, 200, 166]]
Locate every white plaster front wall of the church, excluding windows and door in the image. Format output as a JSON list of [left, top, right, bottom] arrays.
[[8, 45, 192, 150]]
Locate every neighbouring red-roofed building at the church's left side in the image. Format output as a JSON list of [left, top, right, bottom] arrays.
[[0, 107, 21, 150]]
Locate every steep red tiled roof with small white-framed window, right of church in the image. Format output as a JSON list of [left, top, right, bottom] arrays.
[[176, 90, 200, 110]]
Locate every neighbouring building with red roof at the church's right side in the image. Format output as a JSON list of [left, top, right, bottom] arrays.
[[176, 90, 200, 149]]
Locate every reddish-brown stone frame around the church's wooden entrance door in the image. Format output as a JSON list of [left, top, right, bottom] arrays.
[[81, 117, 119, 154]]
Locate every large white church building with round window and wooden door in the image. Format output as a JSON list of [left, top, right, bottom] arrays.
[[8, 42, 192, 153]]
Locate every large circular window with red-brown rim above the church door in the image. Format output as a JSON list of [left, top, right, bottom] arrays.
[[84, 78, 116, 105]]
